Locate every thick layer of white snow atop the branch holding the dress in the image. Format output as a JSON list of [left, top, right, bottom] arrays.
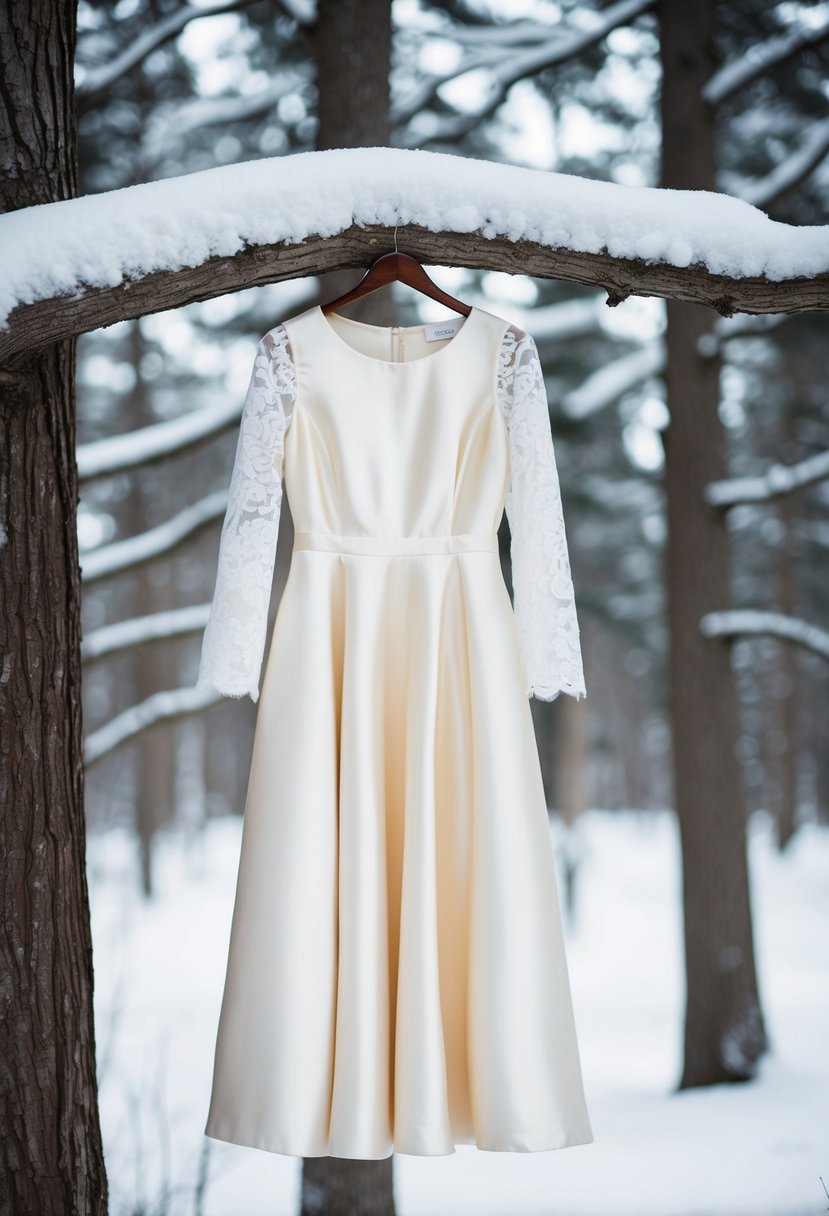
[[0, 147, 829, 328]]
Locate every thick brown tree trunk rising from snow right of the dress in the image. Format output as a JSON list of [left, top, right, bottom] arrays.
[[660, 0, 767, 1088]]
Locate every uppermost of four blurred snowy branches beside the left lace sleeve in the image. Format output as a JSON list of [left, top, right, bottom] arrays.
[[77, 398, 242, 482]]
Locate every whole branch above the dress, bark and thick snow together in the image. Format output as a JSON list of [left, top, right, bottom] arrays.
[[0, 147, 829, 362]]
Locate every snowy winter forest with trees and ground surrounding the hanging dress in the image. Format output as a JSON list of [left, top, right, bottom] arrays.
[[0, 0, 829, 1216]]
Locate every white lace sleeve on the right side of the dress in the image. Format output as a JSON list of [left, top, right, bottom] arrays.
[[497, 326, 587, 700]]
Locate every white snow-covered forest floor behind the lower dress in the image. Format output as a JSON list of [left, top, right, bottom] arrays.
[[89, 811, 829, 1216]]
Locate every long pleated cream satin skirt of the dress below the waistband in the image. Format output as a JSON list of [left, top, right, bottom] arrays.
[[205, 531, 593, 1159]]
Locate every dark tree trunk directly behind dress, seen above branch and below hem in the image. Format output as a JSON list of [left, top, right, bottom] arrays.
[[301, 0, 395, 1216]]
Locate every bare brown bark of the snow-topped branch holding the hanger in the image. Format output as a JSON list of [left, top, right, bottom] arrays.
[[6, 220, 829, 364]]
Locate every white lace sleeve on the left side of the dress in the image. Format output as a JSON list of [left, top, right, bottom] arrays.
[[196, 325, 297, 702]]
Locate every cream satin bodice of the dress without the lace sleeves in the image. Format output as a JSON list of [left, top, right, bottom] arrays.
[[284, 309, 509, 541]]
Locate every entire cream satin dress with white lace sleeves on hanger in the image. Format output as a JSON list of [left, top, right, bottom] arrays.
[[196, 306, 593, 1159]]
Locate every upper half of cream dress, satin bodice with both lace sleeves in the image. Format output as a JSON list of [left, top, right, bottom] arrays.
[[196, 306, 586, 702]]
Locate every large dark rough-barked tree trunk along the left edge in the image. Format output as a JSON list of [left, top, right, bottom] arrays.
[[0, 0, 107, 1216]]
